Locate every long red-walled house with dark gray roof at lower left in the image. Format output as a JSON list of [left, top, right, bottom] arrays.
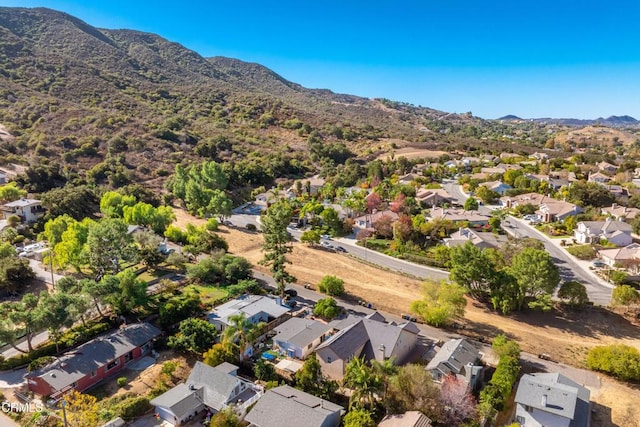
[[26, 323, 160, 400]]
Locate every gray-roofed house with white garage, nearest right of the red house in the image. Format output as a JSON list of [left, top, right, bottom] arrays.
[[150, 362, 263, 426]]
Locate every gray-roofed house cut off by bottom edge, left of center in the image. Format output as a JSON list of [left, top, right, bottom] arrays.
[[245, 385, 344, 427]]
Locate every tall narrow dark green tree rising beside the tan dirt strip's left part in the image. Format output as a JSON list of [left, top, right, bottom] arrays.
[[260, 200, 295, 297]]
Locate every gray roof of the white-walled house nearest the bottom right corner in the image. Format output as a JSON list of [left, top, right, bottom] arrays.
[[515, 373, 590, 427]]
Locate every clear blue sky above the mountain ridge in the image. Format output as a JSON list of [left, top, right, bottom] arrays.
[[0, 0, 640, 119]]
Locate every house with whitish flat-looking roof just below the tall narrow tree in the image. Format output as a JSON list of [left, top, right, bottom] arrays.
[[207, 295, 291, 331]]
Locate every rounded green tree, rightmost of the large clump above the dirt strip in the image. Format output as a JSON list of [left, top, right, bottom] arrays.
[[508, 248, 560, 310]]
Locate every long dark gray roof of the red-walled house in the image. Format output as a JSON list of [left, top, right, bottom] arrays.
[[29, 323, 160, 390]]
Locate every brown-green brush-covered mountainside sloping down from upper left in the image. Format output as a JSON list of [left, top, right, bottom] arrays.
[[0, 8, 636, 191]]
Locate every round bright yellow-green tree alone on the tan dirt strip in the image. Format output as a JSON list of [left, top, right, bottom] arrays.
[[411, 281, 467, 327]]
